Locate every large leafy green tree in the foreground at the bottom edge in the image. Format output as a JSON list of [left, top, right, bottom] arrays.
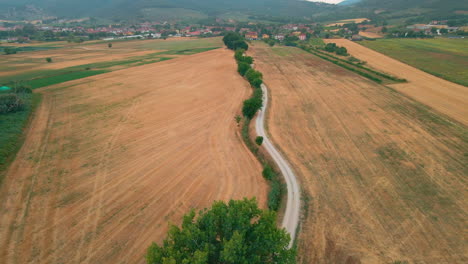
[[146, 199, 295, 264]]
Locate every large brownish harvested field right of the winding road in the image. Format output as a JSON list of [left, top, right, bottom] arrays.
[[249, 43, 468, 264]]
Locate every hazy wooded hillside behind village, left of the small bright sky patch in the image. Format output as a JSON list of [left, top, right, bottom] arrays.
[[0, 0, 334, 19]]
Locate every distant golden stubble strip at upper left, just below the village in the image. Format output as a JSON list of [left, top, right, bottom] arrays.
[[0, 38, 221, 79]]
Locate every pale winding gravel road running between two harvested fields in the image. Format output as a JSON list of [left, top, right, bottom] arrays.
[[255, 84, 301, 248]]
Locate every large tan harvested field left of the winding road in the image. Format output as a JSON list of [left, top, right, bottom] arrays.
[[0, 49, 267, 263]]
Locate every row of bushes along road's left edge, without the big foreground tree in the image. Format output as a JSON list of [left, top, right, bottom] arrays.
[[223, 32, 285, 214]]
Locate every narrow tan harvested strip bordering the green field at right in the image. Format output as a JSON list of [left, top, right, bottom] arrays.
[[325, 39, 468, 125]]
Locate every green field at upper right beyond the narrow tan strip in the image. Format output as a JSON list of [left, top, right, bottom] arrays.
[[360, 38, 468, 86]]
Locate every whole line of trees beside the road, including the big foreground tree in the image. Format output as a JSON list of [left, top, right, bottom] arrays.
[[146, 33, 296, 264]]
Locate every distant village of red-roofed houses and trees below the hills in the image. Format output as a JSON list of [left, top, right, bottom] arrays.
[[0, 18, 468, 43]]
